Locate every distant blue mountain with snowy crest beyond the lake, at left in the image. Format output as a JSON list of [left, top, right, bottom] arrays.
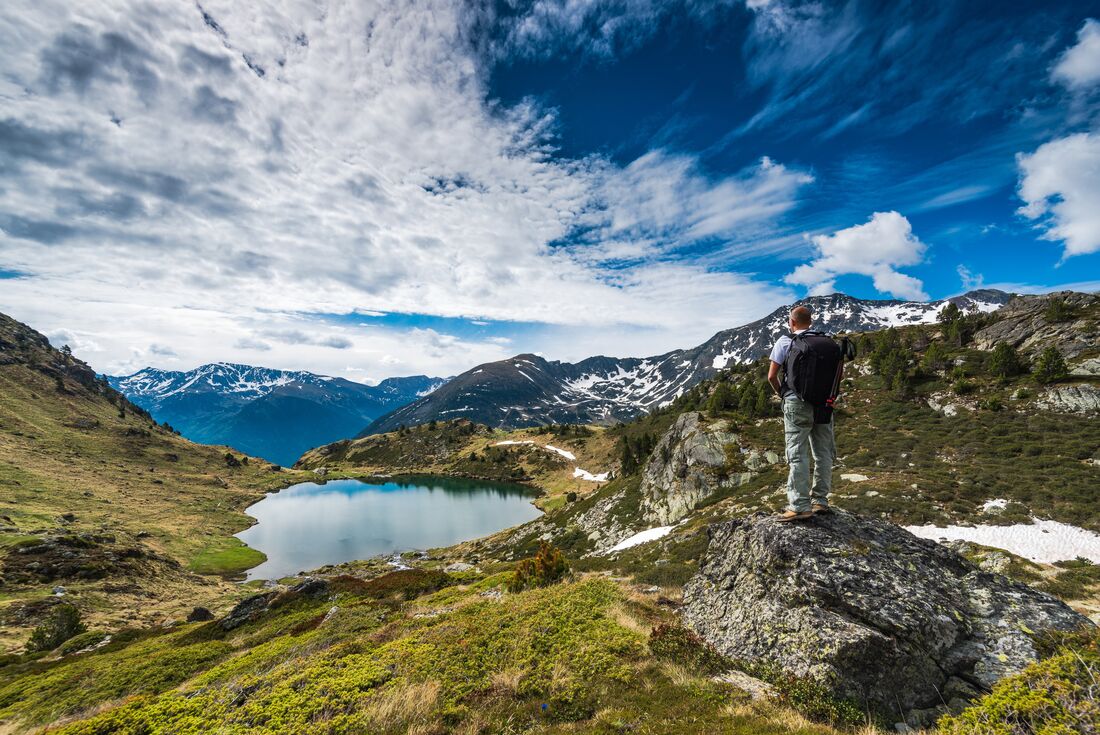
[[108, 363, 444, 467]]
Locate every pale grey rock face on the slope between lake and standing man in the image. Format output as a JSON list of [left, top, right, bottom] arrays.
[[641, 412, 765, 526]]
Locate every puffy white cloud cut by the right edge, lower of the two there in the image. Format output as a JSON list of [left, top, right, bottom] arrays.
[[1016, 133, 1100, 257]]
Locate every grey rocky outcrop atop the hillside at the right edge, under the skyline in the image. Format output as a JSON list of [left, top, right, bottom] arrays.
[[974, 290, 1100, 361]]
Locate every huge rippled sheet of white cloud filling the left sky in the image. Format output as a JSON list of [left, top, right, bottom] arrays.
[[0, 0, 807, 372]]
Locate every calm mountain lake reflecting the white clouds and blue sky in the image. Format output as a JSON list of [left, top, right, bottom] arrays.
[[237, 476, 540, 580]]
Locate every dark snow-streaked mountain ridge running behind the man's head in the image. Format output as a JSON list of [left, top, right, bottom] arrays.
[[359, 289, 1012, 436]]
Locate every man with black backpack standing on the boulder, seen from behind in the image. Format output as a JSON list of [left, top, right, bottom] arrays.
[[768, 306, 844, 522]]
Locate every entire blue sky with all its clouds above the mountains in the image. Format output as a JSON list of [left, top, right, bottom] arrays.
[[0, 0, 1100, 381]]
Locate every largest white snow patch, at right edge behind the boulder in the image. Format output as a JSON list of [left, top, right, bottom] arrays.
[[905, 520, 1100, 564]]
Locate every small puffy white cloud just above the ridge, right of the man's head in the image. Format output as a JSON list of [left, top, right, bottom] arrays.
[[785, 211, 928, 300]]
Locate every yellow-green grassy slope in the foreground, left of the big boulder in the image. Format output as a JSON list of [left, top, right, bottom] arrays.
[[0, 575, 853, 735]]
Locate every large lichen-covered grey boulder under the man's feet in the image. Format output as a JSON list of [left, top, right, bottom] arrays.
[[683, 512, 1091, 726]]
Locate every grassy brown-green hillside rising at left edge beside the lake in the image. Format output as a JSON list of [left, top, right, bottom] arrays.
[[0, 315, 310, 650]]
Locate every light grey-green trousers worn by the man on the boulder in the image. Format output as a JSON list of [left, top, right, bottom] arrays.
[[783, 395, 836, 513]]
